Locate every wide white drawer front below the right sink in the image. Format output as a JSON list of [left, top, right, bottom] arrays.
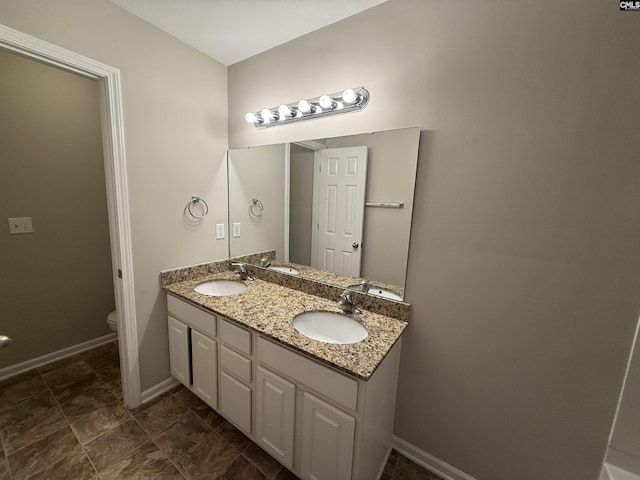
[[257, 337, 358, 410]]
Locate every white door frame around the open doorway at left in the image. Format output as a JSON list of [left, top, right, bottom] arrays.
[[0, 24, 141, 407]]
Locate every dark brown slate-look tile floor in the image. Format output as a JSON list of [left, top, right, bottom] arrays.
[[0, 343, 441, 480]]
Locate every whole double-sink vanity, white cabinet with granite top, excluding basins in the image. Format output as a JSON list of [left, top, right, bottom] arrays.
[[163, 264, 406, 480]]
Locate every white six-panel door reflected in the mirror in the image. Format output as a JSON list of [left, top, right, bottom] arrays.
[[312, 146, 367, 277]]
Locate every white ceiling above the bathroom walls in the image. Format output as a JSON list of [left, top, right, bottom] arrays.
[[111, 0, 387, 65]]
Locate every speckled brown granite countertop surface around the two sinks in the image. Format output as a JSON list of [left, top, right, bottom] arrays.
[[164, 272, 407, 380]]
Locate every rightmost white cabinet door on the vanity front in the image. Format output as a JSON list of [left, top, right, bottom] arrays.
[[301, 392, 355, 480]]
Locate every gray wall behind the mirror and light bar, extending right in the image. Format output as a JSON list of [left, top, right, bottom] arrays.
[[229, 0, 640, 480]]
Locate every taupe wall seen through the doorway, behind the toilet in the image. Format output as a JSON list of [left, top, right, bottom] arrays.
[[0, 50, 115, 368]]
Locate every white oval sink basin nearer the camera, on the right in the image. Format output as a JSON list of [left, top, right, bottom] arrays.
[[293, 312, 368, 343]]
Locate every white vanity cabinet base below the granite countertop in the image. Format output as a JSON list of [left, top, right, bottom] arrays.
[[167, 295, 400, 480]]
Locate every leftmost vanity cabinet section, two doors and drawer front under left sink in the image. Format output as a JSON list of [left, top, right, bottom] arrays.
[[167, 295, 218, 408]]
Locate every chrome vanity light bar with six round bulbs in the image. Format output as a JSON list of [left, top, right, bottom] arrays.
[[245, 87, 369, 128]]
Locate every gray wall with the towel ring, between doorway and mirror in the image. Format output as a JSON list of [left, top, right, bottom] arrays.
[[0, 0, 228, 389]]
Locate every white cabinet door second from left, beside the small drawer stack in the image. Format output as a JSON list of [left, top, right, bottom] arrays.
[[191, 330, 218, 408]]
